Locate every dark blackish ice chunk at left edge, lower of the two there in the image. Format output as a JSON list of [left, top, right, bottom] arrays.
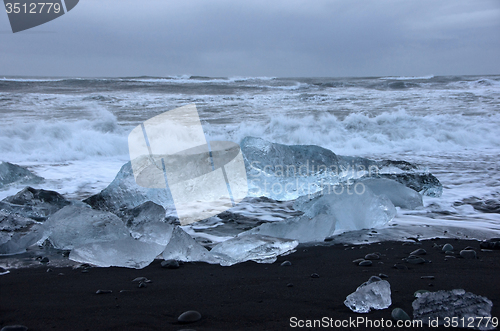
[[0, 186, 72, 222]]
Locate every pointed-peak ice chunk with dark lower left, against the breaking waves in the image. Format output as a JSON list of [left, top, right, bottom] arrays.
[[83, 162, 174, 213]]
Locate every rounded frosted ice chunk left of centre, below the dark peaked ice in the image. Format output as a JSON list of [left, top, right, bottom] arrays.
[[46, 205, 130, 249]]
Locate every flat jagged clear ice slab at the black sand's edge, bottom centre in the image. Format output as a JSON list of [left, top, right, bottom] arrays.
[[210, 234, 299, 266]]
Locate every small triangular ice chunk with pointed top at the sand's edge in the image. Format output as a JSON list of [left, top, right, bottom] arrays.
[[162, 226, 219, 264]]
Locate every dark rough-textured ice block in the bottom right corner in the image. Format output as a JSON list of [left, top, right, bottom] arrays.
[[412, 289, 495, 330]]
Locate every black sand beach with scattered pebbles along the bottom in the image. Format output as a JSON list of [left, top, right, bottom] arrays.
[[0, 239, 500, 330]]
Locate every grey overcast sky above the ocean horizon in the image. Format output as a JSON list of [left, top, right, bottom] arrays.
[[0, 0, 500, 77]]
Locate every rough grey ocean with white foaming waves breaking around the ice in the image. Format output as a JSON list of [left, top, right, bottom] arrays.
[[0, 75, 500, 252]]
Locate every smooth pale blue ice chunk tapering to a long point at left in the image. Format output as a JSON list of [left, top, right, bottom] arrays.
[[248, 186, 396, 243]]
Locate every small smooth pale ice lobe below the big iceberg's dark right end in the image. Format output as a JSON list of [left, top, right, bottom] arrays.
[[359, 178, 423, 209]]
